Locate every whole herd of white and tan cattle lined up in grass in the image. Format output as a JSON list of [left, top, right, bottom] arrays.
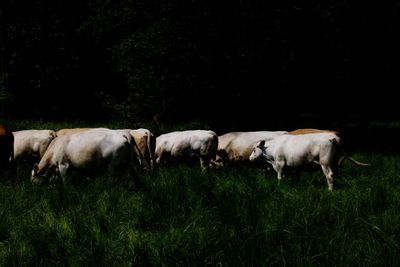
[[0, 125, 368, 190]]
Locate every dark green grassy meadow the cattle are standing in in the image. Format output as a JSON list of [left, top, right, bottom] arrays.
[[0, 121, 400, 266]]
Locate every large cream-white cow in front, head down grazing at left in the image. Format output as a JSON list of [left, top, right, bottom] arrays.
[[31, 128, 136, 183]]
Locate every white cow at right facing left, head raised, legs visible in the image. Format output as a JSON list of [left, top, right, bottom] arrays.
[[249, 133, 365, 190]]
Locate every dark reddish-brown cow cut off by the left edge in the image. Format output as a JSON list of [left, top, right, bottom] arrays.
[[0, 124, 18, 182]]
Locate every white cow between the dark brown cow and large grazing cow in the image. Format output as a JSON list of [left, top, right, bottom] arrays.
[[13, 130, 56, 161]]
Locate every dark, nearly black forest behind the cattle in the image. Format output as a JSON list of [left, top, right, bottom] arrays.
[[0, 0, 400, 132]]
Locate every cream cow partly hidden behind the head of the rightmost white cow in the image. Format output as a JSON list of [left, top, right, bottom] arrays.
[[214, 131, 287, 165]]
